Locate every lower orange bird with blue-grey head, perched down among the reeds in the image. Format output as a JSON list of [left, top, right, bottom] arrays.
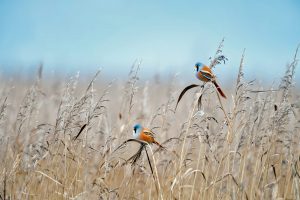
[[133, 124, 164, 148]]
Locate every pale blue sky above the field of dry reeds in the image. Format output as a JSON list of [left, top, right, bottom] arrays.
[[0, 0, 300, 83]]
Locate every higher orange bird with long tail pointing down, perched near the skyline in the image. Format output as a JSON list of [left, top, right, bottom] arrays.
[[195, 62, 226, 99]]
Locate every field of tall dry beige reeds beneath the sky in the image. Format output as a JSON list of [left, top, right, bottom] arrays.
[[0, 45, 300, 199]]
